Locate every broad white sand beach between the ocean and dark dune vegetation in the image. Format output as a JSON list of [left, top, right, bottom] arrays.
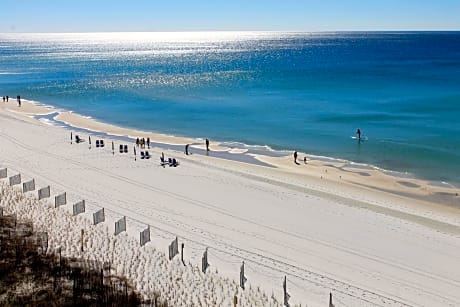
[[0, 101, 460, 307]]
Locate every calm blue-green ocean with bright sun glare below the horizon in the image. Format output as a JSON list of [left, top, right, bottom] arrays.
[[0, 32, 460, 184]]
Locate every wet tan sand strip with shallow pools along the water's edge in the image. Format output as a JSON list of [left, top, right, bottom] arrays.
[[1, 99, 460, 209]]
